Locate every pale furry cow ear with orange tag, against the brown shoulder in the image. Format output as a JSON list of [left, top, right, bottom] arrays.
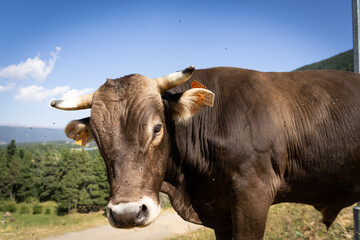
[[172, 88, 215, 122]]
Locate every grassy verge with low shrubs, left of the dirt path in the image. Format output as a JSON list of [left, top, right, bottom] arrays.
[[0, 201, 107, 240]]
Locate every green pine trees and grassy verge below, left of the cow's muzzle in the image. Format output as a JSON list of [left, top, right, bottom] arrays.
[[0, 141, 109, 240]]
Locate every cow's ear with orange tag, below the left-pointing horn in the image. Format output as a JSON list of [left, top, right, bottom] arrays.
[[65, 118, 93, 146]]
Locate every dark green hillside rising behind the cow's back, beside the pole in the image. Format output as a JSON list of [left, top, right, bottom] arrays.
[[295, 50, 354, 72]]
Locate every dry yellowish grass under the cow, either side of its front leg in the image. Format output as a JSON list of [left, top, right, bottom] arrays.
[[171, 203, 354, 240]]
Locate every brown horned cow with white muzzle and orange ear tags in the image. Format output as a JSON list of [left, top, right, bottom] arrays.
[[51, 67, 360, 240]]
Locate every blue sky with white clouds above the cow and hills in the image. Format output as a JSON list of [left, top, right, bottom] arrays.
[[0, 0, 352, 127]]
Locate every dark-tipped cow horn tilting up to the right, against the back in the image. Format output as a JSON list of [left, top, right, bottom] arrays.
[[155, 66, 195, 93]]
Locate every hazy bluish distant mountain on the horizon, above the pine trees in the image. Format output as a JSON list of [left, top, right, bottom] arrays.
[[0, 126, 69, 145]]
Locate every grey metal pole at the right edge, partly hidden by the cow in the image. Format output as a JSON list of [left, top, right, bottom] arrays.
[[352, 0, 360, 240]]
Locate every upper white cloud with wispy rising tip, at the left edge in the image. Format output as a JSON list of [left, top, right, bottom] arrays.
[[0, 47, 61, 82]]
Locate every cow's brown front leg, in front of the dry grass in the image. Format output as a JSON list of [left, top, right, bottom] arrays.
[[231, 173, 274, 240]]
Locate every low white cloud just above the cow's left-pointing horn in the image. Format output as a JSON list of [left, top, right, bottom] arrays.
[[15, 85, 93, 103]]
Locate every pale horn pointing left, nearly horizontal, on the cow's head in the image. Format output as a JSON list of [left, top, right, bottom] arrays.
[[50, 93, 94, 110]]
